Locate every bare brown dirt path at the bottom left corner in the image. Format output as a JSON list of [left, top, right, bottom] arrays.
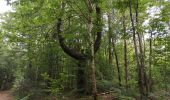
[[0, 91, 13, 100]]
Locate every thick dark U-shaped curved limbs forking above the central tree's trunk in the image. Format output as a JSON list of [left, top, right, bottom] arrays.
[[57, 6, 102, 60]]
